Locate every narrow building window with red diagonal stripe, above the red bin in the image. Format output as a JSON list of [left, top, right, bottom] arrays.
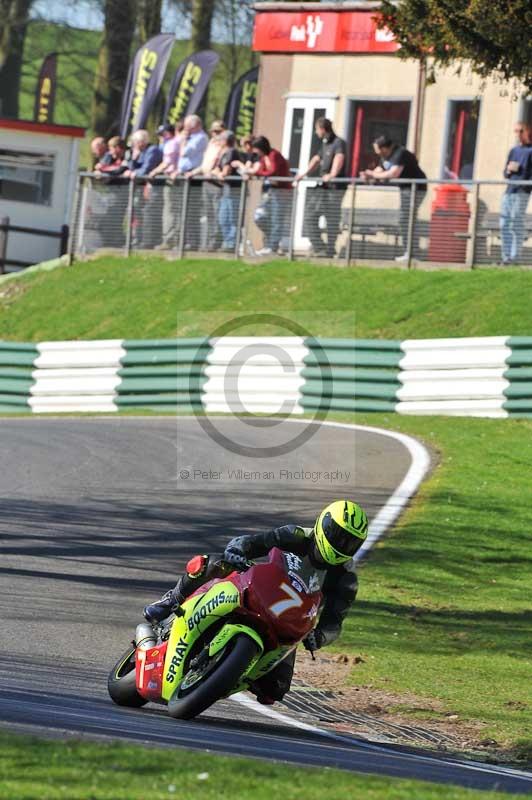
[[442, 100, 480, 179]]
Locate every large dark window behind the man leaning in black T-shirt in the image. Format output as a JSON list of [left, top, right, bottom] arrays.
[[347, 100, 410, 177]]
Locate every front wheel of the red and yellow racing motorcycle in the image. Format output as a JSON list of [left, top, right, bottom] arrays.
[[168, 634, 259, 719]]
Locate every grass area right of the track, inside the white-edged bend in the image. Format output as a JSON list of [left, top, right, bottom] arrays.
[[335, 415, 532, 763]]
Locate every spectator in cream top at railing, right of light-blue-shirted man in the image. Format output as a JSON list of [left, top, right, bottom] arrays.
[[186, 119, 225, 251]]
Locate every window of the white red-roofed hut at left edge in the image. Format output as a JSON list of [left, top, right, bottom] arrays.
[[0, 149, 54, 206]]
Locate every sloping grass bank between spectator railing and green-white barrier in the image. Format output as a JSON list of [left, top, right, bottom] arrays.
[[0, 257, 532, 341]]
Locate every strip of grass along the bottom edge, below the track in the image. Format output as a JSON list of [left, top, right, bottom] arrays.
[[0, 734, 523, 800]]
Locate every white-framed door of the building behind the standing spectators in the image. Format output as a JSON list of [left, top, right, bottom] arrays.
[[283, 97, 335, 250]]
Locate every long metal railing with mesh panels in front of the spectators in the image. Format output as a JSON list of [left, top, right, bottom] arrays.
[[69, 173, 532, 268]]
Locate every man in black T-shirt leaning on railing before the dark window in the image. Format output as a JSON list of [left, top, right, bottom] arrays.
[[360, 136, 427, 262]]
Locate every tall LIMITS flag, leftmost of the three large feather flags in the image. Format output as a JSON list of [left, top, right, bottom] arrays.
[[120, 33, 175, 139]]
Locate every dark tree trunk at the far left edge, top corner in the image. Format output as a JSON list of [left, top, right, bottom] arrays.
[[0, 0, 32, 118]]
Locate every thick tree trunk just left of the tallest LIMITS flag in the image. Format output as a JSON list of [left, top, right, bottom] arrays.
[[91, 0, 136, 137]]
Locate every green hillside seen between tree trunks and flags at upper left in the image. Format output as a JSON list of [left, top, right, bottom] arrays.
[[19, 20, 254, 166]]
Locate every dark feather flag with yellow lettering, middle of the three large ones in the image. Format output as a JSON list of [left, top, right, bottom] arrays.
[[164, 50, 220, 124]]
